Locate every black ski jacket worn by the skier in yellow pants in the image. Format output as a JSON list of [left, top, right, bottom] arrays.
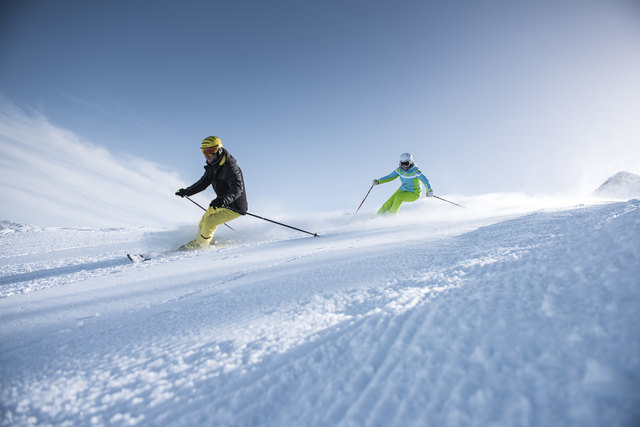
[[185, 148, 249, 215]]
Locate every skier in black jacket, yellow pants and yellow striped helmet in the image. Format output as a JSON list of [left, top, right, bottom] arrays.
[[176, 136, 248, 249]]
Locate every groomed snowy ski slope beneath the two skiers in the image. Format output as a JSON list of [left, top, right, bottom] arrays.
[[0, 200, 640, 426]]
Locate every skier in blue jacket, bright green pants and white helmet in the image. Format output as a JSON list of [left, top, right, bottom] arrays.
[[373, 153, 433, 215]]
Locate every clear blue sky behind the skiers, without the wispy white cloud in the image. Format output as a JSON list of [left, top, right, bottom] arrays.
[[0, 0, 640, 227]]
